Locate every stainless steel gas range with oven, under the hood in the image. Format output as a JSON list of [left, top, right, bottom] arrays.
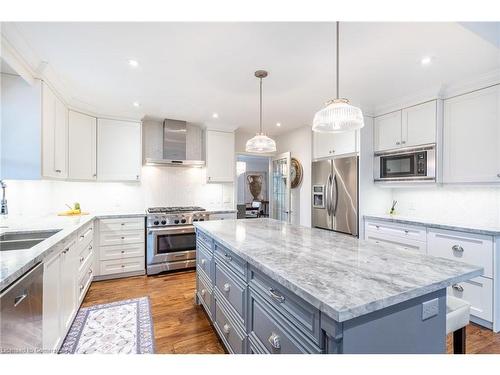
[[146, 207, 209, 275]]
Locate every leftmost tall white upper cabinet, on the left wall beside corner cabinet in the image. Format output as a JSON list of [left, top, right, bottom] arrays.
[[42, 83, 68, 178]]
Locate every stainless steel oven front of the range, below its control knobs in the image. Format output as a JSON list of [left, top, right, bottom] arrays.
[[146, 225, 196, 274]]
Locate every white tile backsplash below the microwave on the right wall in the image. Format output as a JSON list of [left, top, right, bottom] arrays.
[[392, 185, 500, 226]]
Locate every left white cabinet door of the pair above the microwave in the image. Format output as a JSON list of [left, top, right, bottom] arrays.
[[373, 111, 401, 151]]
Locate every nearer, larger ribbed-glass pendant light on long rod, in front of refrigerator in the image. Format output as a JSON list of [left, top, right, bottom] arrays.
[[312, 21, 365, 133]]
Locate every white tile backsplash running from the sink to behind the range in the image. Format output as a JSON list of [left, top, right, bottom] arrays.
[[6, 166, 234, 216]]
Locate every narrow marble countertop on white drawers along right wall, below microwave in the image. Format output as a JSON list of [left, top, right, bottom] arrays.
[[364, 214, 500, 236]]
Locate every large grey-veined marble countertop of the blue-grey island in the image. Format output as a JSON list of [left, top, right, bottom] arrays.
[[195, 219, 483, 322]]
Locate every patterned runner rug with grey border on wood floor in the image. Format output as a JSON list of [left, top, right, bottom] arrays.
[[59, 297, 154, 354]]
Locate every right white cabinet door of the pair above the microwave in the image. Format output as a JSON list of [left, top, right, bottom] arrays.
[[401, 100, 437, 147]]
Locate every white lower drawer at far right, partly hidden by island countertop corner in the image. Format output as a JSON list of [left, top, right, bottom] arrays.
[[448, 276, 493, 322]]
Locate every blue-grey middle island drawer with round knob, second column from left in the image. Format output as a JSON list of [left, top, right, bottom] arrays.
[[215, 262, 246, 324]]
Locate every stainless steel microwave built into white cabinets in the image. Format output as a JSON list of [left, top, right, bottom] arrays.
[[373, 145, 436, 182]]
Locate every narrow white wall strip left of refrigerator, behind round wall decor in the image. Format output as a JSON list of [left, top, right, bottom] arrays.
[[276, 126, 312, 227]]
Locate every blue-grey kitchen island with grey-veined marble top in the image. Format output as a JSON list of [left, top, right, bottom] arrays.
[[195, 219, 483, 353]]
